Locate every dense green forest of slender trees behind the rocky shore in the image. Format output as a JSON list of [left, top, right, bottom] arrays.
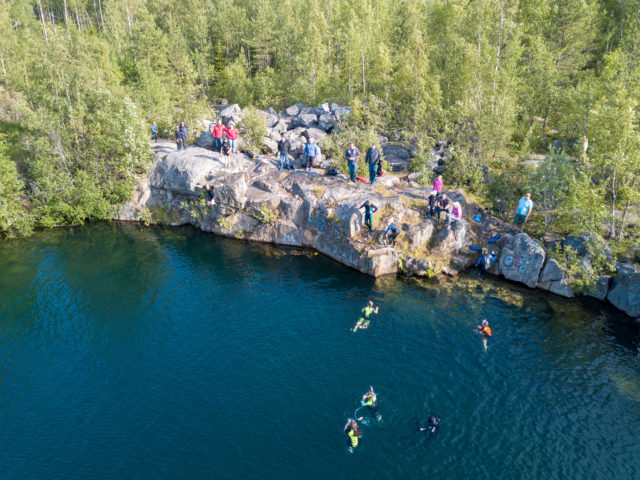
[[0, 0, 640, 253]]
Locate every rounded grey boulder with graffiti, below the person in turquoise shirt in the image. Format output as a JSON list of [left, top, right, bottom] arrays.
[[499, 233, 545, 288]]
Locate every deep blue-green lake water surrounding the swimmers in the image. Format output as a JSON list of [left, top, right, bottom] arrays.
[[0, 224, 640, 479]]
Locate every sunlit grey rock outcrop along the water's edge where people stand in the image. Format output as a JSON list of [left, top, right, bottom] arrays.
[[116, 142, 640, 316]]
